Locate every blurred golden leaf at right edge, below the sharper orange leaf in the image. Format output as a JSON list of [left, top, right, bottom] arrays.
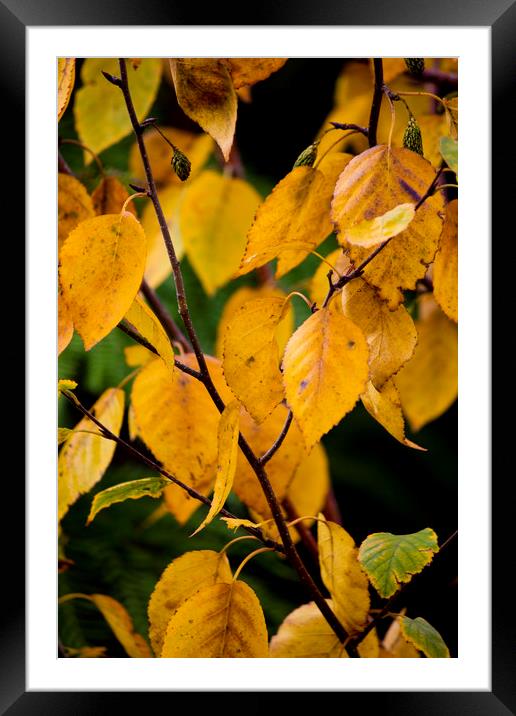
[[395, 294, 458, 431]]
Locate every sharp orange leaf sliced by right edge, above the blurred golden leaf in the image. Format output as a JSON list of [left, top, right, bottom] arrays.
[[433, 199, 459, 323]]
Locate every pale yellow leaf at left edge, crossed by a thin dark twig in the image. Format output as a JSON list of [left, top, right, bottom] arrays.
[[57, 388, 124, 520]]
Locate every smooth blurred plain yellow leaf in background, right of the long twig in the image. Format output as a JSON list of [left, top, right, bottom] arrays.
[[179, 170, 261, 295]]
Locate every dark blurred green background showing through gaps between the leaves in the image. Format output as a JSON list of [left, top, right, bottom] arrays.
[[58, 59, 458, 657]]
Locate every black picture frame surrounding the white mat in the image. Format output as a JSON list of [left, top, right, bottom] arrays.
[[9, 0, 516, 716]]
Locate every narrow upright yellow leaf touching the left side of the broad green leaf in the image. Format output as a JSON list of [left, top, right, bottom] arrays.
[[317, 514, 370, 633]]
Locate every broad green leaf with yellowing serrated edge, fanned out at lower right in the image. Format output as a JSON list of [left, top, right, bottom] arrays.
[[358, 527, 439, 598]]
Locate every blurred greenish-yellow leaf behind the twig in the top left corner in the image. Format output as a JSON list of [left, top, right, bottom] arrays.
[[73, 57, 161, 164]]
